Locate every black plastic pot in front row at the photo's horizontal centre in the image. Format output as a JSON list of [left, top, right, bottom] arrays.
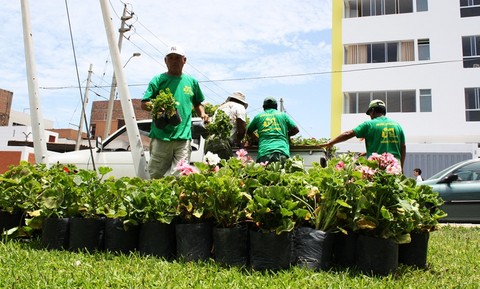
[[213, 226, 248, 267]]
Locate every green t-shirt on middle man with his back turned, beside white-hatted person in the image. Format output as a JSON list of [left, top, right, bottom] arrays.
[[247, 109, 297, 159]]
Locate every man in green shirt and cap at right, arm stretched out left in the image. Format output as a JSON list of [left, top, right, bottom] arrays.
[[321, 99, 406, 170]]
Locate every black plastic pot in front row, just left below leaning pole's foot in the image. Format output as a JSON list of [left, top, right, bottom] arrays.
[[105, 219, 139, 253]]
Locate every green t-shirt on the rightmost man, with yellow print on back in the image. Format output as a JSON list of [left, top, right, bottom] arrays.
[[353, 116, 405, 160]]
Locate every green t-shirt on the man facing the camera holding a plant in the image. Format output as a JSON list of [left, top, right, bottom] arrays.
[[142, 73, 205, 141]]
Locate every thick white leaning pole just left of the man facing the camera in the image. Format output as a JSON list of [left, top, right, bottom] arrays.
[[100, 0, 150, 179]]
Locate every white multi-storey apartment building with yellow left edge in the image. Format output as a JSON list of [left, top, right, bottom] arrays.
[[331, 0, 480, 176]]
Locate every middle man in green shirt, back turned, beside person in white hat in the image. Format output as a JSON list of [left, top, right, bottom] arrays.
[[247, 97, 299, 163]]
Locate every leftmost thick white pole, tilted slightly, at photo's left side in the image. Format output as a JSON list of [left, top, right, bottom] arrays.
[[21, 0, 48, 165]]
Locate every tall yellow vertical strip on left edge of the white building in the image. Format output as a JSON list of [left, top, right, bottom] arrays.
[[330, 0, 343, 138]]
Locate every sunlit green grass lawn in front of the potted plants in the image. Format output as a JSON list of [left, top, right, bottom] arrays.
[[0, 226, 480, 289]]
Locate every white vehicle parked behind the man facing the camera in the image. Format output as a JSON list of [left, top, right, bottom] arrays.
[[49, 118, 205, 177]]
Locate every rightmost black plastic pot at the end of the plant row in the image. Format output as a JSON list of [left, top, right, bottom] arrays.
[[398, 232, 430, 268]]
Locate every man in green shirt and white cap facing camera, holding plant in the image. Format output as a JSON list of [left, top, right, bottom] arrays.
[[142, 46, 208, 178]]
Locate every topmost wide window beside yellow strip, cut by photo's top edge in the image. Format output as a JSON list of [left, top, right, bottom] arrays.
[[343, 0, 414, 18]]
